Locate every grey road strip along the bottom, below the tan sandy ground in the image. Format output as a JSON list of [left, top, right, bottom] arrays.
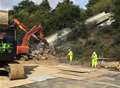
[[14, 66, 120, 88]]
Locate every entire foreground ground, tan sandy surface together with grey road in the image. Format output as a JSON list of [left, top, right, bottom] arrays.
[[0, 64, 120, 88]]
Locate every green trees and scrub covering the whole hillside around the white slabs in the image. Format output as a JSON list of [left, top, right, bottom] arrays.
[[9, 0, 120, 58]]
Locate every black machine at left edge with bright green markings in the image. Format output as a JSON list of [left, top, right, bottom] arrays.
[[0, 27, 16, 62]]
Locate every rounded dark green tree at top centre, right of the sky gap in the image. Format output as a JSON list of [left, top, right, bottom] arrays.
[[54, 0, 81, 29]]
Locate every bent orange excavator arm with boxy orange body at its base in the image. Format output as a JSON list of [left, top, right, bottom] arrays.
[[17, 25, 49, 54]]
